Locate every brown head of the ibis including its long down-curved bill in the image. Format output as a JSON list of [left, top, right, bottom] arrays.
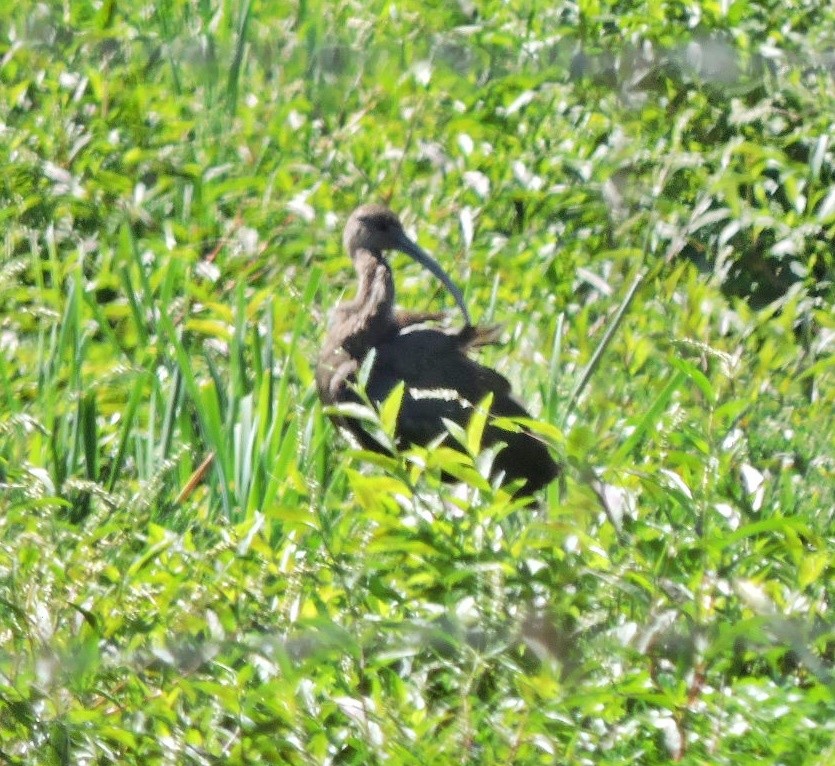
[[342, 203, 471, 325]]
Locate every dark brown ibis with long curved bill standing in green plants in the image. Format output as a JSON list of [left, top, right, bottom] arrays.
[[316, 203, 562, 497]]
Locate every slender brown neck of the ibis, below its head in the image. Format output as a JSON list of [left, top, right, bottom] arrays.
[[343, 250, 397, 357]]
